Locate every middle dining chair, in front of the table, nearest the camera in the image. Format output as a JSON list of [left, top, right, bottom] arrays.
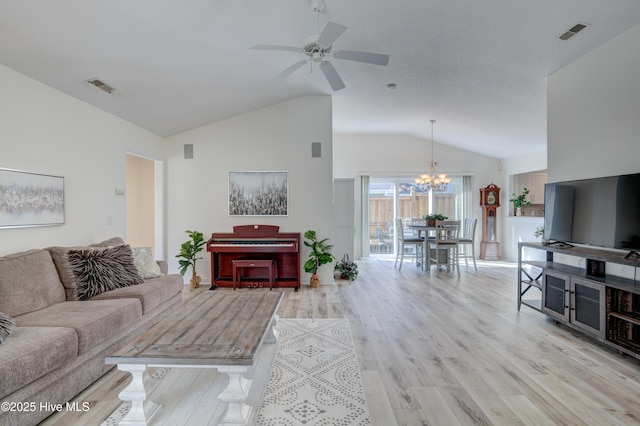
[[427, 220, 460, 276]]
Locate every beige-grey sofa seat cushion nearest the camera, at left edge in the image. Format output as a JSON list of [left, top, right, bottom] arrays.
[[0, 327, 78, 398]]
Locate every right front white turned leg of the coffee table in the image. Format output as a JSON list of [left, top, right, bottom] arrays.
[[218, 365, 251, 426]]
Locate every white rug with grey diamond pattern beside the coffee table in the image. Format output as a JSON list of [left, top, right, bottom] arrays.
[[255, 318, 371, 426]]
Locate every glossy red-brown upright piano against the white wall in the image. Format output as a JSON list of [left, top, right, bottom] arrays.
[[207, 225, 300, 291]]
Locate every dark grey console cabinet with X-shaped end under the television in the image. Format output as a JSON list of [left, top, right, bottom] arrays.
[[518, 242, 640, 359]]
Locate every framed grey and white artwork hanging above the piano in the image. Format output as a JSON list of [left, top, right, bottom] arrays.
[[229, 172, 289, 216]]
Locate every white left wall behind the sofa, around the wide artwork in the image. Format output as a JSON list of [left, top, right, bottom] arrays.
[[0, 66, 164, 256]]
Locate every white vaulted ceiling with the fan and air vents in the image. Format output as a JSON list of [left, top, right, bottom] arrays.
[[0, 0, 640, 158]]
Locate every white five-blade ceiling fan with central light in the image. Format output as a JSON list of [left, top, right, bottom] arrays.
[[250, 0, 389, 91]]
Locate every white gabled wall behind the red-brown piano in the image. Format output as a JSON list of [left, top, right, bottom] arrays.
[[167, 96, 333, 284]]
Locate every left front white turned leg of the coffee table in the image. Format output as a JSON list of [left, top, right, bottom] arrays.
[[118, 364, 161, 426]]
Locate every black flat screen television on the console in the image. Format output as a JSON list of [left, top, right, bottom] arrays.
[[544, 173, 640, 255]]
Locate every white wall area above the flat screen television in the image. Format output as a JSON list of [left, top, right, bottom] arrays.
[[547, 21, 640, 182]]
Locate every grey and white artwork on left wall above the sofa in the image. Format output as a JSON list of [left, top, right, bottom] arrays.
[[0, 169, 64, 228]]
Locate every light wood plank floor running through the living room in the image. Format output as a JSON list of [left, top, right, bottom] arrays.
[[45, 259, 640, 426]]
